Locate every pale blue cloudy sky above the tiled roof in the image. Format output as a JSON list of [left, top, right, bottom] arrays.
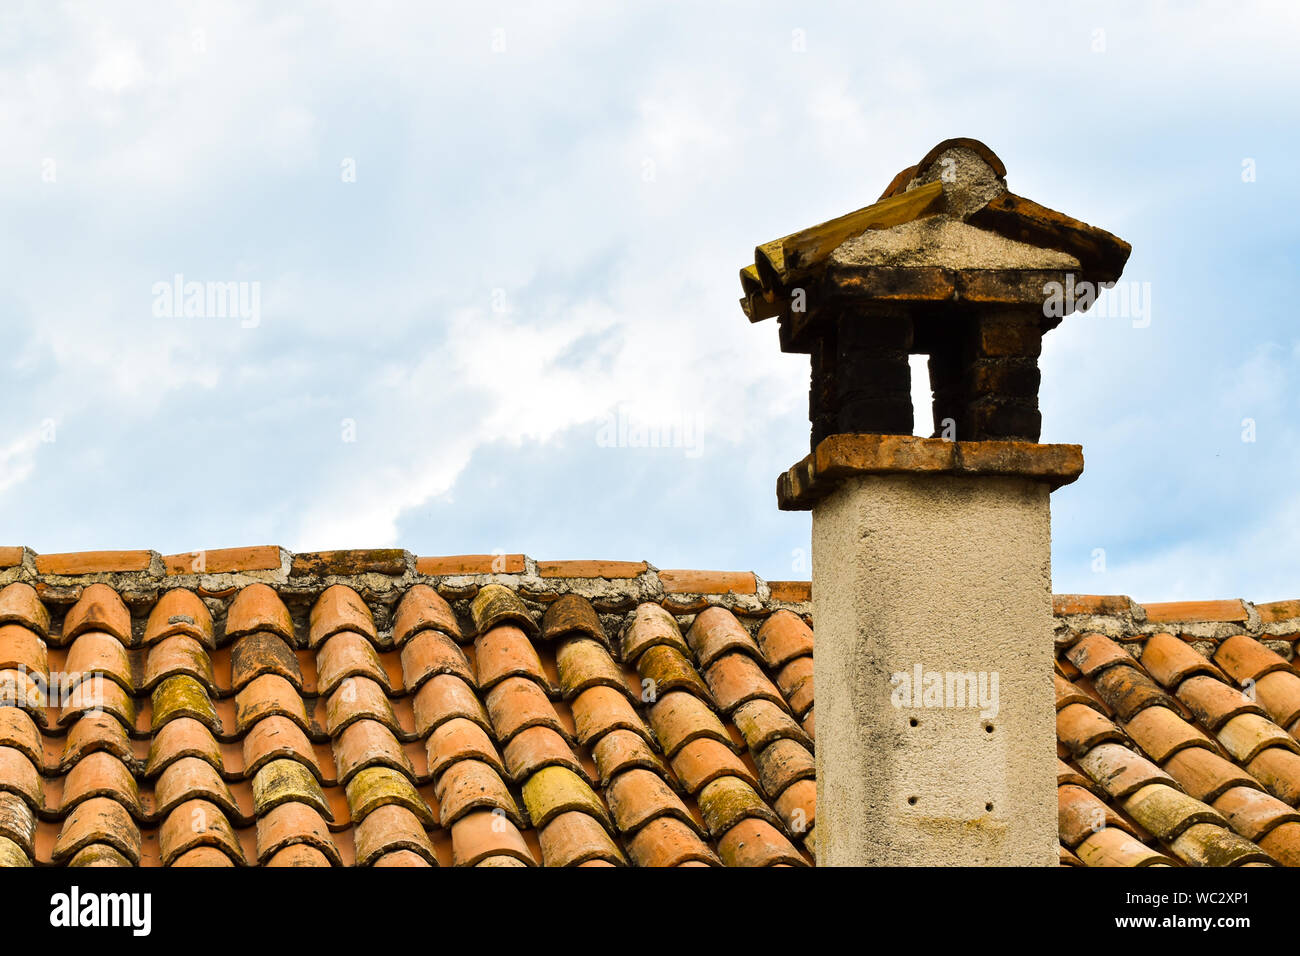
[[0, 0, 1300, 601]]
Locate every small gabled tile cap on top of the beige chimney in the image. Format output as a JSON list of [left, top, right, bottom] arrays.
[[740, 137, 1131, 332]]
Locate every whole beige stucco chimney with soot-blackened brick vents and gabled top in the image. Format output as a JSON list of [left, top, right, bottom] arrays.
[[741, 139, 1130, 866]]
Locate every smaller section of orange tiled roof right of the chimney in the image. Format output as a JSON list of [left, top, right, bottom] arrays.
[[1054, 594, 1300, 866]]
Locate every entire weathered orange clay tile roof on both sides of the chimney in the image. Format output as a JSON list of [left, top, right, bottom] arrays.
[[0, 548, 1300, 866]]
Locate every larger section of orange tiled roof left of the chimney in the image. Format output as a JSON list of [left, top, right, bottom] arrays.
[[0, 548, 816, 866]]
